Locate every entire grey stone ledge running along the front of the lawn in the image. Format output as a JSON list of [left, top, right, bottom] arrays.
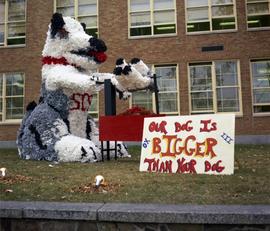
[[0, 201, 270, 225]]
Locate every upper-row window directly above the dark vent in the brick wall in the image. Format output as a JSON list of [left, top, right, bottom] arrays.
[[186, 0, 236, 33]]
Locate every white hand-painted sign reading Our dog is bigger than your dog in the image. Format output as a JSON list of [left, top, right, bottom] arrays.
[[140, 114, 235, 174]]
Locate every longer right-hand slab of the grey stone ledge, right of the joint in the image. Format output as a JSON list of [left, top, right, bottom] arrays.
[[98, 204, 270, 224]]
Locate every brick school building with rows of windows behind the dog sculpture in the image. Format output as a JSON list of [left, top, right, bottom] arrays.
[[0, 0, 270, 145]]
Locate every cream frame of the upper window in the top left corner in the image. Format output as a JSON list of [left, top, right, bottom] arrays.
[[0, 0, 27, 49]]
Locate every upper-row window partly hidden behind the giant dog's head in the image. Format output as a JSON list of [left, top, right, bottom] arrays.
[[55, 0, 98, 37]]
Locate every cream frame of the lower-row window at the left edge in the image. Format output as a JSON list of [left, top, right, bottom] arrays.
[[0, 71, 25, 124]]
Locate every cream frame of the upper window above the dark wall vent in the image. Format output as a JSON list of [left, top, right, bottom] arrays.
[[185, 0, 238, 35]]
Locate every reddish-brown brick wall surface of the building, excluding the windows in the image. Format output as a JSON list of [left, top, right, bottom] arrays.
[[0, 0, 270, 140]]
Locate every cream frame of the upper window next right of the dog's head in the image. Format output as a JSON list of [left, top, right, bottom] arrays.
[[128, 0, 177, 39]]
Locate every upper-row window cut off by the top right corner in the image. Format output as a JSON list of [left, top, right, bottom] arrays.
[[247, 0, 270, 28]]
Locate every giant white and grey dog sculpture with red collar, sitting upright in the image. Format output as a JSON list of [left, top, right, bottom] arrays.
[[17, 13, 151, 162]]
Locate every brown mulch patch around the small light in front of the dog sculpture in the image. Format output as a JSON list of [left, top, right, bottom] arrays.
[[71, 183, 121, 193]]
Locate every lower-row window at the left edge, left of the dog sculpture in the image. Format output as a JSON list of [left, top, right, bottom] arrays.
[[0, 73, 24, 123]]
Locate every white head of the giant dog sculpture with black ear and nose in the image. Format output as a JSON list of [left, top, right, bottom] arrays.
[[42, 13, 107, 70]]
